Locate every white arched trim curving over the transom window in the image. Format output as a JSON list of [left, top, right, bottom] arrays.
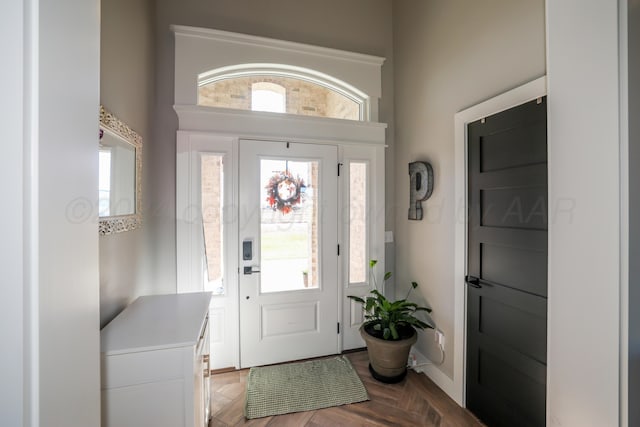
[[198, 64, 370, 121]]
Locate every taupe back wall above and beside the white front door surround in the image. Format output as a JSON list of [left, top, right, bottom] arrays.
[[149, 0, 394, 292]]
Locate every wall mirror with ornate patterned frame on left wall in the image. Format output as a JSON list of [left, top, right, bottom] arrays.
[[98, 105, 142, 235]]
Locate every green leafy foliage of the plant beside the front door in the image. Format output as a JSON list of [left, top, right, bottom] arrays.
[[348, 260, 436, 341]]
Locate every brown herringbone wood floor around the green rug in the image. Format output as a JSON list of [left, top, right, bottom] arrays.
[[209, 351, 483, 427]]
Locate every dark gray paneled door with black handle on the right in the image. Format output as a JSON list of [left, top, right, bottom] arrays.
[[467, 98, 548, 427]]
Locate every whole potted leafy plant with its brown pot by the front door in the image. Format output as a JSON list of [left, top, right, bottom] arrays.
[[348, 260, 435, 383]]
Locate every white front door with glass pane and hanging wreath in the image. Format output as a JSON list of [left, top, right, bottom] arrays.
[[238, 140, 339, 368]]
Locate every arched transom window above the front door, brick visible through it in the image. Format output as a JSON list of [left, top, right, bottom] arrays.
[[198, 66, 367, 120]]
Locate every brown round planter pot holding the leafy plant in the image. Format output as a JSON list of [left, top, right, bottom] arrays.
[[360, 325, 418, 383]]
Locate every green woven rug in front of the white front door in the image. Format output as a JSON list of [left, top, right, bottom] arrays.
[[244, 356, 369, 419]]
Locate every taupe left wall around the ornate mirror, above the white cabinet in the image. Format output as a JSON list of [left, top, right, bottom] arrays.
[[100, 0, 154, 327]]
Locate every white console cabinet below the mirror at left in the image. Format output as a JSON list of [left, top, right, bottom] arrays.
[[100, 292, 211, 427]]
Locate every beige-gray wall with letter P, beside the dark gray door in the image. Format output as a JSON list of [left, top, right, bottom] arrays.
[[393, 0, 545, 377]]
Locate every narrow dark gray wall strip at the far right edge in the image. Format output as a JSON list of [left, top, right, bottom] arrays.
[[628, 0, 640, 426]]
